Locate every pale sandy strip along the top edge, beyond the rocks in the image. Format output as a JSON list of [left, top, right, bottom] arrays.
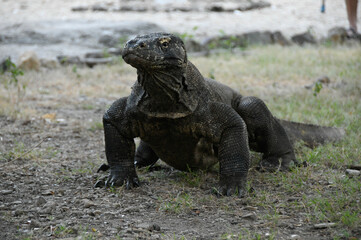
[[0, 0, 361, 37]]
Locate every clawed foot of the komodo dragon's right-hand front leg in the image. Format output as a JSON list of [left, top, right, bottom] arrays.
[[213, 176, 247, 198]]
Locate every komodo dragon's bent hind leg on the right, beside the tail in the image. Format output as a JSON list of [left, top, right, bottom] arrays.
[[232, 96, 298, 170]]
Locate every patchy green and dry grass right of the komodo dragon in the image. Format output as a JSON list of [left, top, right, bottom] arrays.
[[193, 46, 361, 238]]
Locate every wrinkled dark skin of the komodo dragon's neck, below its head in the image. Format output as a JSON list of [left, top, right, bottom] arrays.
[[137, 63, 198, 118]]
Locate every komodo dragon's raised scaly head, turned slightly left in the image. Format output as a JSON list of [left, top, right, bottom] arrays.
[[122, 33, 187, 71]]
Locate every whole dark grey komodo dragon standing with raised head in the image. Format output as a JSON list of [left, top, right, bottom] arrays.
[[100, 33, 343, 196]]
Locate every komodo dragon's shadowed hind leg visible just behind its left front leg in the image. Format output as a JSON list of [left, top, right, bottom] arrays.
[[134, 141, 159, 167]]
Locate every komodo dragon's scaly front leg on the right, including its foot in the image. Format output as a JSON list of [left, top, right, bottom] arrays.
[[218, 125, 249, 197]]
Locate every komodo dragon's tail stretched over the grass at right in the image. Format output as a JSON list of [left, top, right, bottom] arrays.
[[278, 119, 345, 148]]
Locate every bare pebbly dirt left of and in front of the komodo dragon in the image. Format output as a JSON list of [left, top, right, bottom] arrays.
[[0, 92, 348, 239]]
